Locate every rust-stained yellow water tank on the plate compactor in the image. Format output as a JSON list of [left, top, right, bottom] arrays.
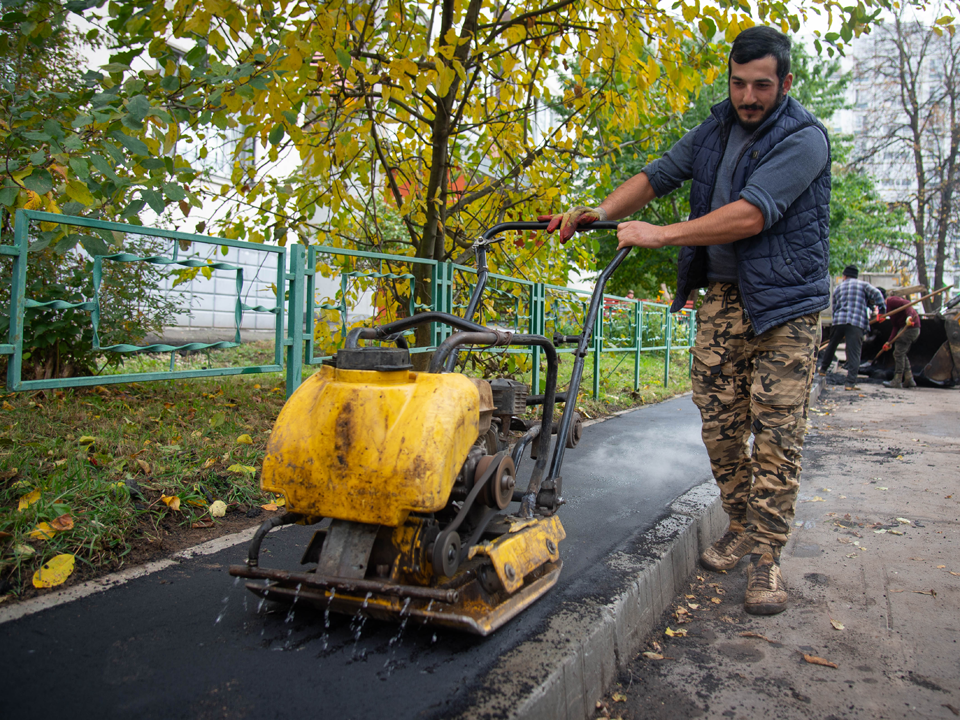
[[260, 366, 480, 527]]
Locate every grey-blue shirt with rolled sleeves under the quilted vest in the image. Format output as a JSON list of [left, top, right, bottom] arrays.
[[643, 122, 829, 282]]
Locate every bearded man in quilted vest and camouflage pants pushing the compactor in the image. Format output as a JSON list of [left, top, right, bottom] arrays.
[[548, 27, 830, 614]]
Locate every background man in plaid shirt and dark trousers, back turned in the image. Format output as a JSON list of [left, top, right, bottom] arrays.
[[820, 265, 883, 390]]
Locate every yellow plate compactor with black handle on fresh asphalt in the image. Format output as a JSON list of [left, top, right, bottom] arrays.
[[230, 222, 629, 635]]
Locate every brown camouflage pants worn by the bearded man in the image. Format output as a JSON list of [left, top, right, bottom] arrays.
[[693, 283, 819, 551]]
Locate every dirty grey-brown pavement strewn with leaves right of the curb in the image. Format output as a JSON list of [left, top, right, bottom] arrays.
[[597, 376, 960, 720]]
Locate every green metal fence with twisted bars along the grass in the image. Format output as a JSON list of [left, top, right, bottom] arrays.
[[0, 210, 694, 398]]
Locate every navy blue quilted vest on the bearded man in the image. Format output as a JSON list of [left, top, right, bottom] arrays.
[[670, 96, 830, 335]]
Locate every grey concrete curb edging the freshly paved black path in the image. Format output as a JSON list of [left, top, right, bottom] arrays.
[[461, 480, 727, 720]]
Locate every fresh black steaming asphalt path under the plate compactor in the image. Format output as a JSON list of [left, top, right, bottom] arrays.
[[0, 396, 710, 720]]
